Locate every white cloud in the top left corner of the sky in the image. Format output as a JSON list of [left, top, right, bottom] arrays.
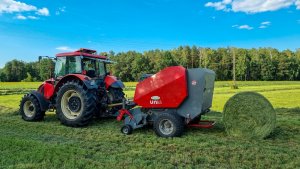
[[0, 0, 50, 19]]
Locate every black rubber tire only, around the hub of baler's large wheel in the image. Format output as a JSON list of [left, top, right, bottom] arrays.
[[153, 112, 184, 138]]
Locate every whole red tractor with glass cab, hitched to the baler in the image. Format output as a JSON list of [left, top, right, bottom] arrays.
[[20, 49, 124, 127]]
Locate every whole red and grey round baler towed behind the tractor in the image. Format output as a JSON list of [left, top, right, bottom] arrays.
[[118, 66, 215, 137]]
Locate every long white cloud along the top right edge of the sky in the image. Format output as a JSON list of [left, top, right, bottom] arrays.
[[205, 0, 300, 13]]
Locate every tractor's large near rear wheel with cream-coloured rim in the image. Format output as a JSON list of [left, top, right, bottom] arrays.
[[56, 81, 97, 127]]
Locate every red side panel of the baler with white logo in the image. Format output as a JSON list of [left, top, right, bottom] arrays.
[[134, 66, 188, 108]]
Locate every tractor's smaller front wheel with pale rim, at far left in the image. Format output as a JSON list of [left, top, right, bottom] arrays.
[[20, 94, 45, 122]]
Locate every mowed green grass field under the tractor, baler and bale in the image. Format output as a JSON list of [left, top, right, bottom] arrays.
[[0, 82, 300, 169]]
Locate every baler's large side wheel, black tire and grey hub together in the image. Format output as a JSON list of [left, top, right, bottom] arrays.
[[153, 112, 184, 137]]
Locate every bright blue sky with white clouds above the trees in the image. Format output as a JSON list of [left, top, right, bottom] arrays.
[[0, 0, 300, 67]]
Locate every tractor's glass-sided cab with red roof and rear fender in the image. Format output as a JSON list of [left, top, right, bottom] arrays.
[[54, 48, 124, 89]]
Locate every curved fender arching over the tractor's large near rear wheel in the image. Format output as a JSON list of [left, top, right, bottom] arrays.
[[55, 74, 98, 93]]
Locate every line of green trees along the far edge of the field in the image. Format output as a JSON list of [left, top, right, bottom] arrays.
[[0, 46, 300, 82]]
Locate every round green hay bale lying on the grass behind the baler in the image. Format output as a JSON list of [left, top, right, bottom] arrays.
[[223, 92, 276, 139]]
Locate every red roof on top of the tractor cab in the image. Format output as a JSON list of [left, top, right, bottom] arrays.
[[56, 48, 107, 59]]
